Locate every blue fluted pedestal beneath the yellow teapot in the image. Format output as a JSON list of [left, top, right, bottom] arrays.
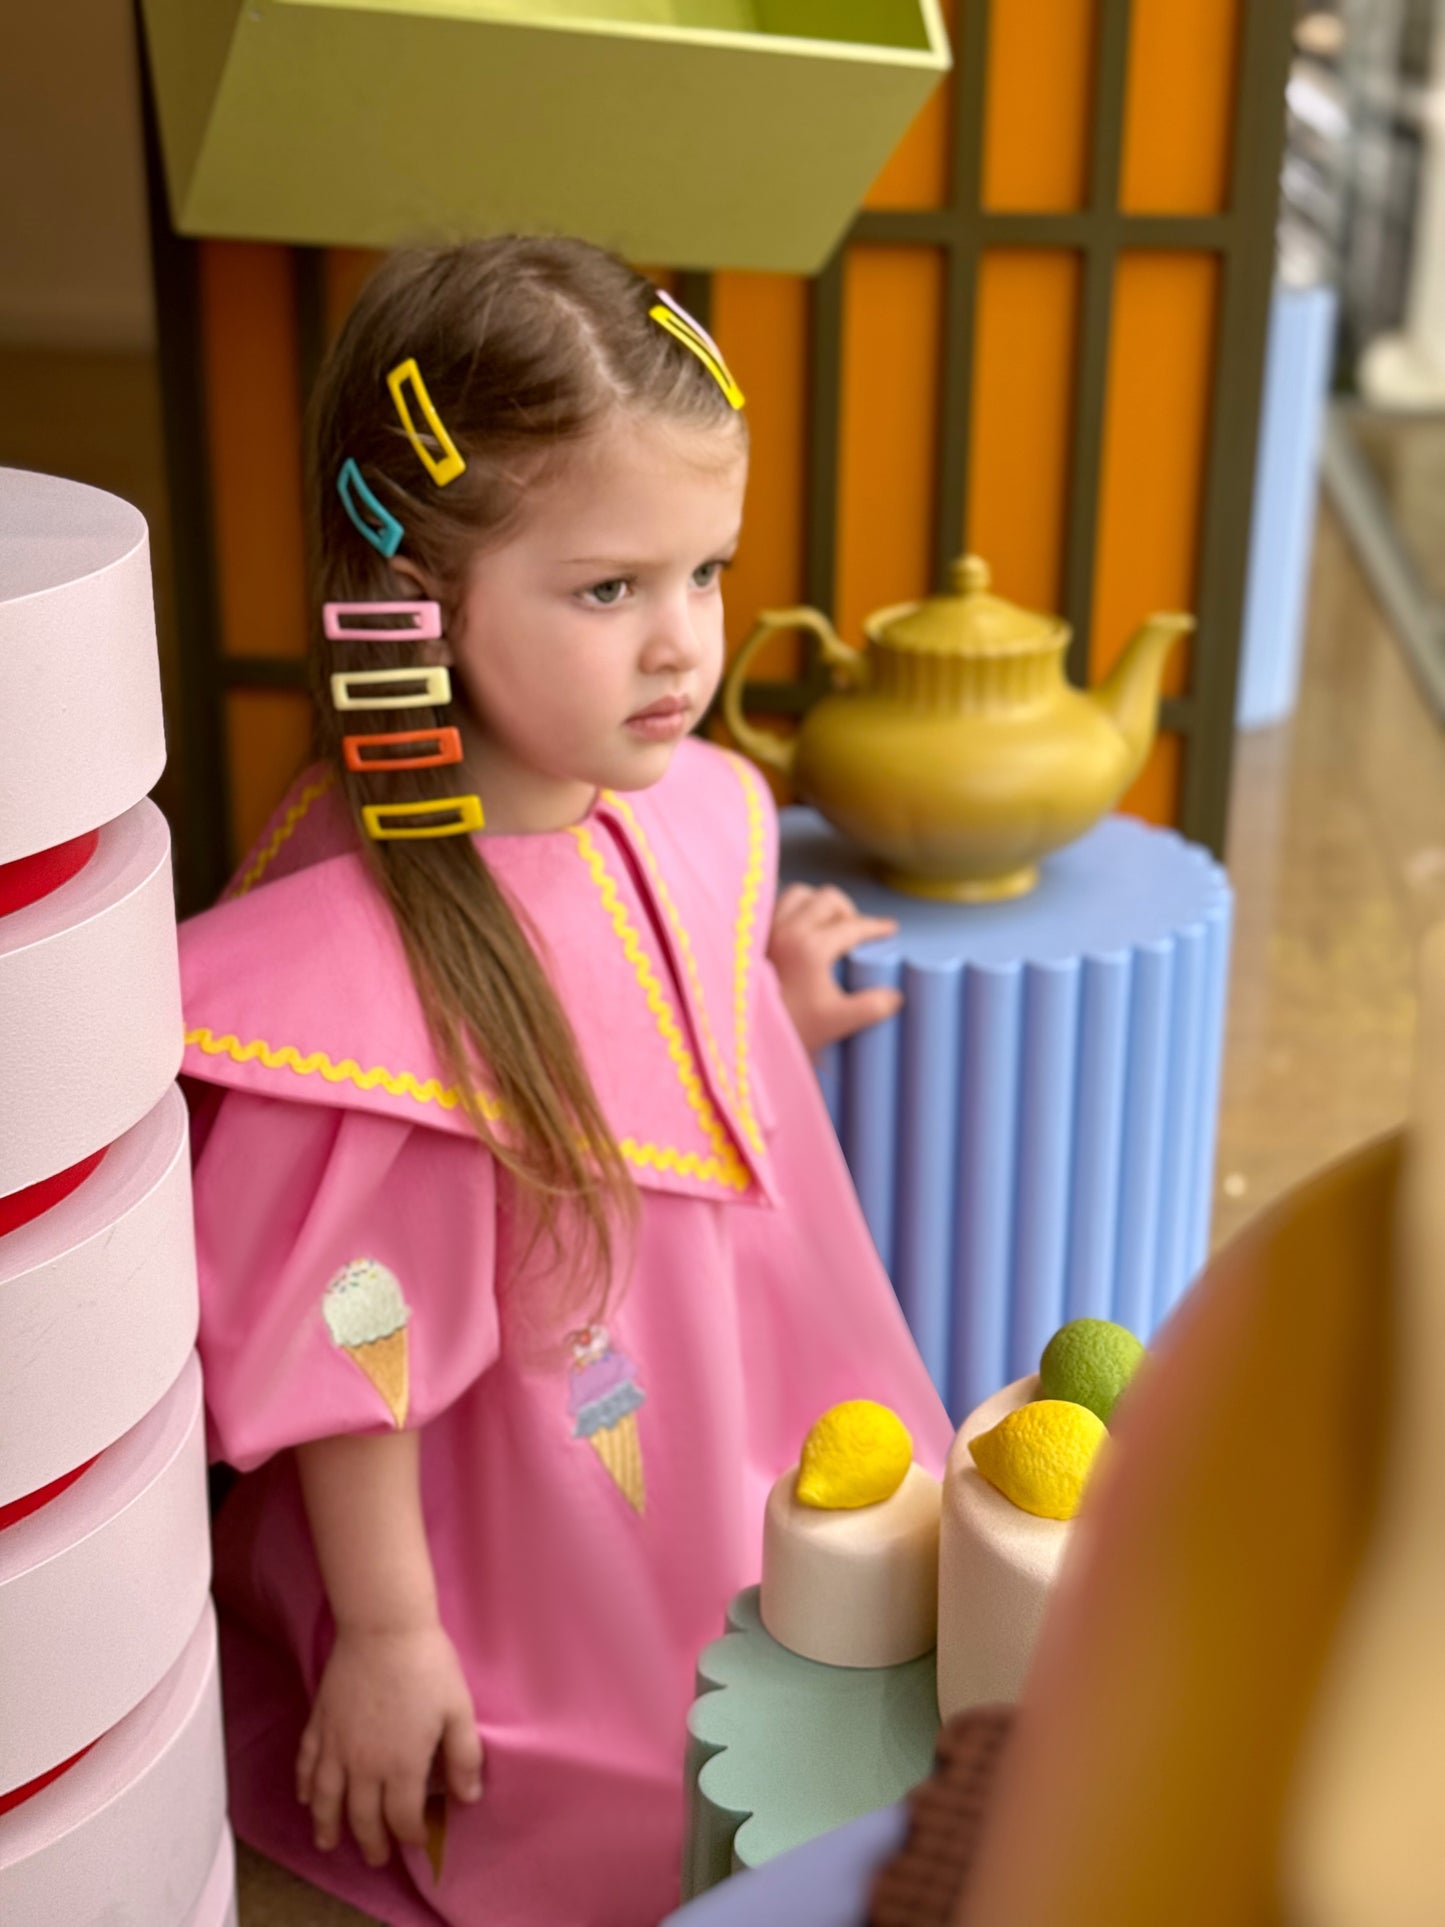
[[782, 809, 1233, 1420]]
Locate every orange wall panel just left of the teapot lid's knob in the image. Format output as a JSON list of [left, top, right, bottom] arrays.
[[836, 247, 944, 644]]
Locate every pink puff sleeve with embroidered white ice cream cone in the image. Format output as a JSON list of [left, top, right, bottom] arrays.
[[189, 1087, 499, 1472]]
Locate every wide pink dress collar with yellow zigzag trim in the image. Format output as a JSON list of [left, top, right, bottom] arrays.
[[181, 740, 776, 1202]]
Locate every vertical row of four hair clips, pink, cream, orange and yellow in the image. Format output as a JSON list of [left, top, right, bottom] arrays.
[[322, 601, 486, 842]]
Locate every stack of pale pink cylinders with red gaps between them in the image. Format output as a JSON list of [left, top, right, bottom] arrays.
[[0, 470, 235, 1927]]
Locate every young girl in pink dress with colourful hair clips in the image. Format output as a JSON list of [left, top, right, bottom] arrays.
[[183, 239, 952, 1927]]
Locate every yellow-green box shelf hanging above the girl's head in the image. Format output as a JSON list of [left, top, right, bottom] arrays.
[[143, 0, 950, 274]]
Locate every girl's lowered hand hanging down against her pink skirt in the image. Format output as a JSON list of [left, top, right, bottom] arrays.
[[297, 1621, 482, 1867]]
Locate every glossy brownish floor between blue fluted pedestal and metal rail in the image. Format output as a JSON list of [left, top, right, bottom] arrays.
[[1216, 497, 1445, 1239]]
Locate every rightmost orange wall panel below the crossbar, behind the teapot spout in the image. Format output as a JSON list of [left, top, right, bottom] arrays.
[[1092, 252, 1220, 712]]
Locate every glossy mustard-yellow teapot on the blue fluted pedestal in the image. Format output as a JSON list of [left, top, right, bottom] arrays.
[[723, 555, 1195, 904]]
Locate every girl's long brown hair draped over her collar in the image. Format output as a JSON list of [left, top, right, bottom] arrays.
[[306, 235, 746, 1318]]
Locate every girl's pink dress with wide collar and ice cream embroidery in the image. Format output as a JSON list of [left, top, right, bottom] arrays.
[[181, 742, 952, 1927]]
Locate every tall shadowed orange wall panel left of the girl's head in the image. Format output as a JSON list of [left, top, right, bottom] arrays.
[[200, 241, 306, 655]]
